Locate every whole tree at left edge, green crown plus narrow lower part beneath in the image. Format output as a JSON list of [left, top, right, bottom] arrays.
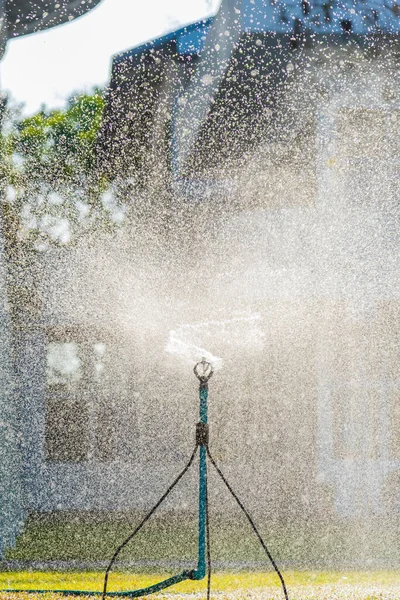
[[0, 90, 124, 331]]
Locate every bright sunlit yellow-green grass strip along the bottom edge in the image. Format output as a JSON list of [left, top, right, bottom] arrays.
[[0, 571, 400, 600]]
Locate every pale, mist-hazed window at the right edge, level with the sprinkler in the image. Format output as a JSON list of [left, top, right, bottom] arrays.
[[331, 301, 400, 468]]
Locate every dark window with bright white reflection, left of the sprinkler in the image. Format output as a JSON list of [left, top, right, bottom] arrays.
[[45, 328, 116, 463]]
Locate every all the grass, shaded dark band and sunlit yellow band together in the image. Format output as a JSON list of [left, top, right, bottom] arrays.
[[4, 514, 400, 600]]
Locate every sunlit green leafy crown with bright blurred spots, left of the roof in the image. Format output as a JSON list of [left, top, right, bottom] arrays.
[[0, 90, 122, 250]]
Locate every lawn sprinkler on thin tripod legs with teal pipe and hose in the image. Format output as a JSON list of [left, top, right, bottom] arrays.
[[0, 358, 289, 600]]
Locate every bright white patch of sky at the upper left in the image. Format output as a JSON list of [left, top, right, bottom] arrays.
[[0, 0, 220, 114]]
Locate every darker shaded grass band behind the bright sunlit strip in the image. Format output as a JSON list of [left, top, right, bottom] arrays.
[[7, 514, 400, 569]]
